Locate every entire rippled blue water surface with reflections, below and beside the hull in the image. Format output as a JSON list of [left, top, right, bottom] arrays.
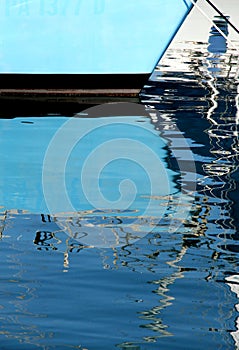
[[0, 28, 239, 350]]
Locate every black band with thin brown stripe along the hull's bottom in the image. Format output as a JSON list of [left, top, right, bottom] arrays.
[[0, 74, 150, 118]]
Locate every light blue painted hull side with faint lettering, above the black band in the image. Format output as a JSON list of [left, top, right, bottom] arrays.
[[0, 0, 192, 74]]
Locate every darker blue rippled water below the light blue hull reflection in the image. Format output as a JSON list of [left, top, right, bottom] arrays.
[[1, 214, 236, 349]]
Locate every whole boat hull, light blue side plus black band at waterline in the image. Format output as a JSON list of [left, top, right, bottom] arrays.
[[0, 0, 192, 112]]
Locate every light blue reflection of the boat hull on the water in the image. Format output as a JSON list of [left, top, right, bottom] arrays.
[[0, 110, 193, 247]]
